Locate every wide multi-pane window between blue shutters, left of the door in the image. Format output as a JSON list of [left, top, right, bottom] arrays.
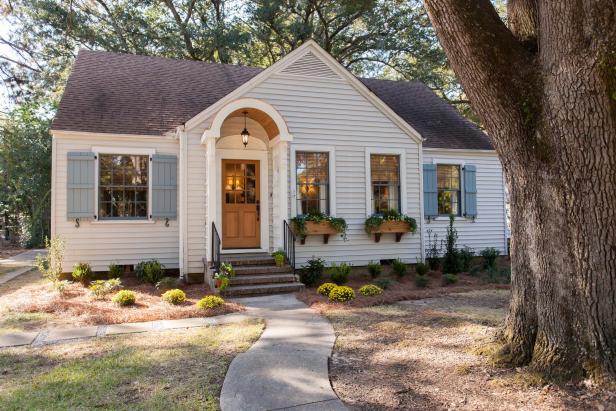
[[98, 154, 149, 219]]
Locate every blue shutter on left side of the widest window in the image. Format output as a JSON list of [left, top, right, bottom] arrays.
[[66, 152, 96, 219]]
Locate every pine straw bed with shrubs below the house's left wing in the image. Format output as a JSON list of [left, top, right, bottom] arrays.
[[0, 271, 245, 330]]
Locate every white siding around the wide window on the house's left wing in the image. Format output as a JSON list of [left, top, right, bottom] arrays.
[[52, 136, 179, 272]]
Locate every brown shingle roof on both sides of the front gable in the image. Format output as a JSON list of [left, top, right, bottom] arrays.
[[52, 50, 492, 150]]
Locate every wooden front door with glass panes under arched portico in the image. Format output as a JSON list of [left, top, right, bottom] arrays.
[[222, 160, 261, 249]]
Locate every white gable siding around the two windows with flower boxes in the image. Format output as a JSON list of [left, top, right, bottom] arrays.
[[246, 74, 421, 265]]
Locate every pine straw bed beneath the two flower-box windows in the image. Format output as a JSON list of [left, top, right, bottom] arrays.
[[295, 271, 510, 313]]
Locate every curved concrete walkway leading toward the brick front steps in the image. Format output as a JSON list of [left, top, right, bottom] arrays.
[[220, 295, 347, 411]]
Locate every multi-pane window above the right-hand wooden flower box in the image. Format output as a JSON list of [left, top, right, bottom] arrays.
[[370, 154, 400, 213]]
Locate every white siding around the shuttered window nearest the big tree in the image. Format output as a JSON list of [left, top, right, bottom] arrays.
[[423, 149, 506, 254]]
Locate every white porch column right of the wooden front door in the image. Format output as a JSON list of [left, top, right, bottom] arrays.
[[272, 137, 289, 250]]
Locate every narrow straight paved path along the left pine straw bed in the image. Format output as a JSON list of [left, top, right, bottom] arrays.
[[0, 313, 254, 348]]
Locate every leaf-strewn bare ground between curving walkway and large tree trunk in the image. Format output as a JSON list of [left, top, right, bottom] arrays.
[[325, 290, 616, 411]]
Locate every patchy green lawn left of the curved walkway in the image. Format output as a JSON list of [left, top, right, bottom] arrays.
[[0, 320, 263, 410]]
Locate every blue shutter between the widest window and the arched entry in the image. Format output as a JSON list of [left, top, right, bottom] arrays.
[[151, 154, 178, 219]]
